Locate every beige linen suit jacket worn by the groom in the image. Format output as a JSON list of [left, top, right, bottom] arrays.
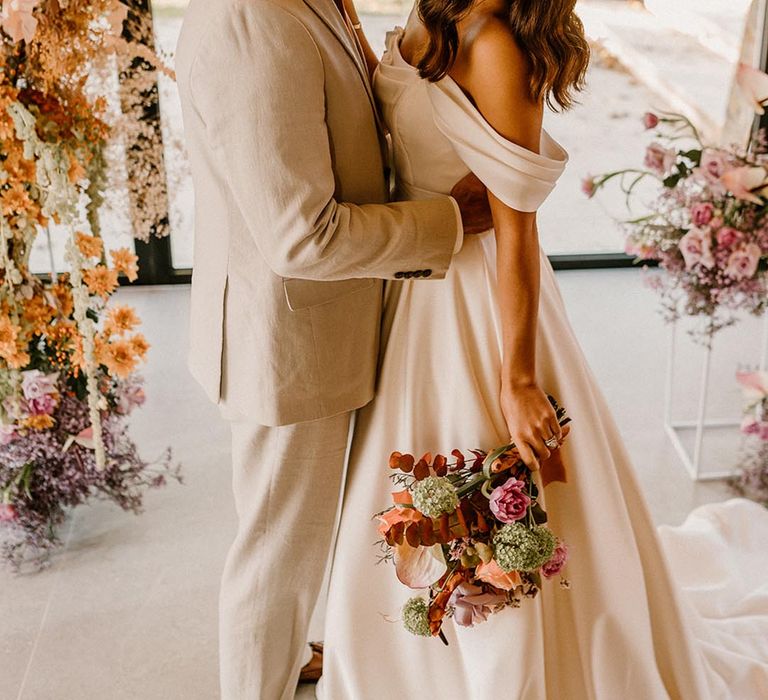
[[176, 0, 461, 425]]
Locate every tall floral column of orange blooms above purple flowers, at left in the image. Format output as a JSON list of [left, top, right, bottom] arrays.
[[0, 0, 179, 567]]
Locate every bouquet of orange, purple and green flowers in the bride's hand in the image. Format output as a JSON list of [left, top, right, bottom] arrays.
[[376, 402, 570, 644]]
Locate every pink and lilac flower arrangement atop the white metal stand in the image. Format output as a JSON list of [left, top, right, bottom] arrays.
[[583, 65, 768, 339]]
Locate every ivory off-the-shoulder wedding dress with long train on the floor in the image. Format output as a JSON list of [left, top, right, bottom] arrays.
[[318, 30, 768, 700]]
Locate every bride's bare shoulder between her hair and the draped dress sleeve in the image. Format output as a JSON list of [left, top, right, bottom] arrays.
[[450, 15, 543, 150]]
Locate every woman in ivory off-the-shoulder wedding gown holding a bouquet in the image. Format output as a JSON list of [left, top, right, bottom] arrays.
[[319, 0, 768, 700]]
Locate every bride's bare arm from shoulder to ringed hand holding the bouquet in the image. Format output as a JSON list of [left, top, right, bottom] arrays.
[[451, 20, 561, 468]]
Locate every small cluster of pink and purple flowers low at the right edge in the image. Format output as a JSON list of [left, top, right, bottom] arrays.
[[730, 372, 768, 506]]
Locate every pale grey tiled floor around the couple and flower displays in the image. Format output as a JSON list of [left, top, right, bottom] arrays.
[[0, 270, 759, 700]]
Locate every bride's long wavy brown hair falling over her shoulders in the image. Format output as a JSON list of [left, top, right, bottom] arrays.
[[417, 0, 589, 110]]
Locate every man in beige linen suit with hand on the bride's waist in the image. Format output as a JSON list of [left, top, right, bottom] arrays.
[[177, 0, 491, 700]]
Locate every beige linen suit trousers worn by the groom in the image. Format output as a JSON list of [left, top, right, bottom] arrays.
[[219, 413, 352, 700]]
